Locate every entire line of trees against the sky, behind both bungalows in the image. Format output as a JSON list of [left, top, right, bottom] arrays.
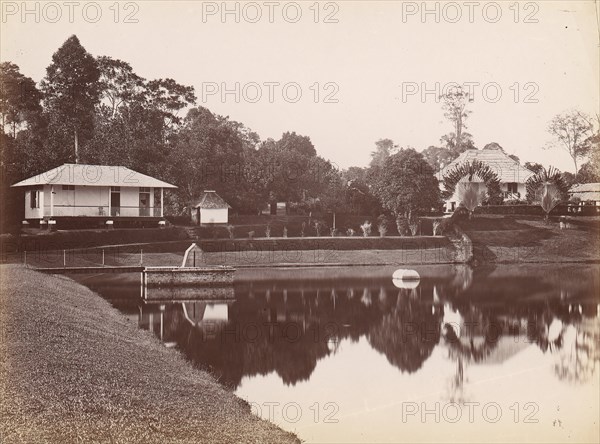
[[0, 36, 600, 232]]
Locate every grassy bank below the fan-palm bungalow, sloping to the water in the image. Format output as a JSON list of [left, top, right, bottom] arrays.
[[459, 215, 600, 263]]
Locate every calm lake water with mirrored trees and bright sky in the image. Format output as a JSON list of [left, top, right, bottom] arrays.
[[77, 265, 600, 443]]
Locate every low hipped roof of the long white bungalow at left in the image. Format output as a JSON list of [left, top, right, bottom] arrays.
[[12, 163, 177, 188]]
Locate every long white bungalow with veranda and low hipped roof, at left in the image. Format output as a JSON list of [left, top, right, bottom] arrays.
[[12, 163, 177, 221]]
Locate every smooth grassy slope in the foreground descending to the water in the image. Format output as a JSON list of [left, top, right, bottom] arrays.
[[0, 265, 298, 443]]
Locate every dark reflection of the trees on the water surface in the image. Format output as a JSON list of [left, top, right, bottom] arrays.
[[85, 267, 600, 392]]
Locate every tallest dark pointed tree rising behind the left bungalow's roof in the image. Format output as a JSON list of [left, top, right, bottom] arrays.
[[41, 35, 100, 162]]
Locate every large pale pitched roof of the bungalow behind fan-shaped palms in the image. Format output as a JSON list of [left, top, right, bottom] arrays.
[[436, 143, 533, 183]]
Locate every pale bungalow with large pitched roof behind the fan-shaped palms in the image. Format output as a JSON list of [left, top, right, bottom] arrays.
[[436, 143, 533, 212]]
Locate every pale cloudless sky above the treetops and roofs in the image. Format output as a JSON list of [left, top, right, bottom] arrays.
[[0, 1, 600, 171]]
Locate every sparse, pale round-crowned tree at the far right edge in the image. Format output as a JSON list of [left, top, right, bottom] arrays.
[[548, 110, 593, 174]]
